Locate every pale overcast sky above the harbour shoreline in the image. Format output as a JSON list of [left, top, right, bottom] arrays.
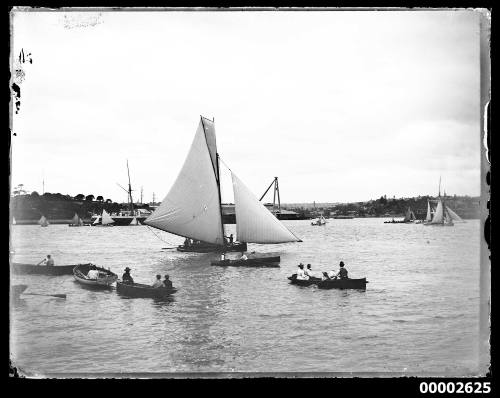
[[11, 10, 484, 203]]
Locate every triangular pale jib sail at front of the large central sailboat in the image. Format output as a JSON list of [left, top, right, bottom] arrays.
[[231, 172, 301, 243]]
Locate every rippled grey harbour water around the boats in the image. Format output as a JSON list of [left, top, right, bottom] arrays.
[[10, 219, 486, 375]]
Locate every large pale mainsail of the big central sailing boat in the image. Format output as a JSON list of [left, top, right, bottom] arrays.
[[145, 119, 224, 245]]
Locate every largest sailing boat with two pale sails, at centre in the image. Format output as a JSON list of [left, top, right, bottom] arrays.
[[144, 116, 301, 252]]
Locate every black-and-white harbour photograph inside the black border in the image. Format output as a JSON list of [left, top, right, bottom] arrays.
[[9, 7, 491, 380]]
